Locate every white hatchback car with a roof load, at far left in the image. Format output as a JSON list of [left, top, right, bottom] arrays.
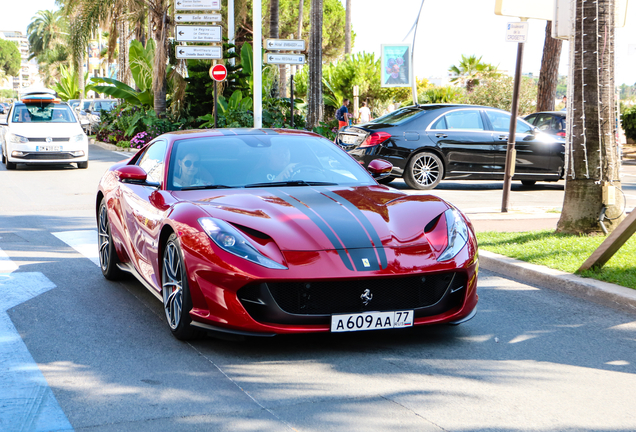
[[0, 91, 88, 170]]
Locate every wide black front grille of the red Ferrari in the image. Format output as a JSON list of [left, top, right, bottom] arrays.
[[267, 273, 454, 315]]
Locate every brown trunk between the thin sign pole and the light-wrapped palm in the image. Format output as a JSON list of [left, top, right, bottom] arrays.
[[537, 21, 563, 111]]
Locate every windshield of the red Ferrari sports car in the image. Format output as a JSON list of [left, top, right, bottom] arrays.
[[167, 134, 375, 190]]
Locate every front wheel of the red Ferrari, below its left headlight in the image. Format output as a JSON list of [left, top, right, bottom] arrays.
[[161, 234, 200, 340]]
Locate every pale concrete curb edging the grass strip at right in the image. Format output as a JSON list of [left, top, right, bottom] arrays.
[[479, 250, 636, 312]]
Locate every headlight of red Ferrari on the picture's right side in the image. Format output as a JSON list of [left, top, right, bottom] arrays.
[[424, 208, 468, 261]]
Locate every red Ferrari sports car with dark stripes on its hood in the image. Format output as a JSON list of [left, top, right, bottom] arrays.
[[96, 129, 478, 339]]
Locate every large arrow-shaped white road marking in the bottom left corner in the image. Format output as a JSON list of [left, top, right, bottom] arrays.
[[0, 249, 73, 431]]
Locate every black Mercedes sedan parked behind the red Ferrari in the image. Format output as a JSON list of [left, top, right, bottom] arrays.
[[336, 104, 565, 190]]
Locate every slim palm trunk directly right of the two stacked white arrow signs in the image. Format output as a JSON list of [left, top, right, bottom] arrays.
[[307, 0, 323, 129]]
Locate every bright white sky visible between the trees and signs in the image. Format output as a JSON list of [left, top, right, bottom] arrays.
[[0, 0, 636, 85]]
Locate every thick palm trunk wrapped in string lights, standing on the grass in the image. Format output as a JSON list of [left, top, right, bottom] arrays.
[[557, 0, 624, 233]]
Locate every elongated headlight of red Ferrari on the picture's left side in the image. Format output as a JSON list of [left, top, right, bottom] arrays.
[[199, 217, 287, 270]]
